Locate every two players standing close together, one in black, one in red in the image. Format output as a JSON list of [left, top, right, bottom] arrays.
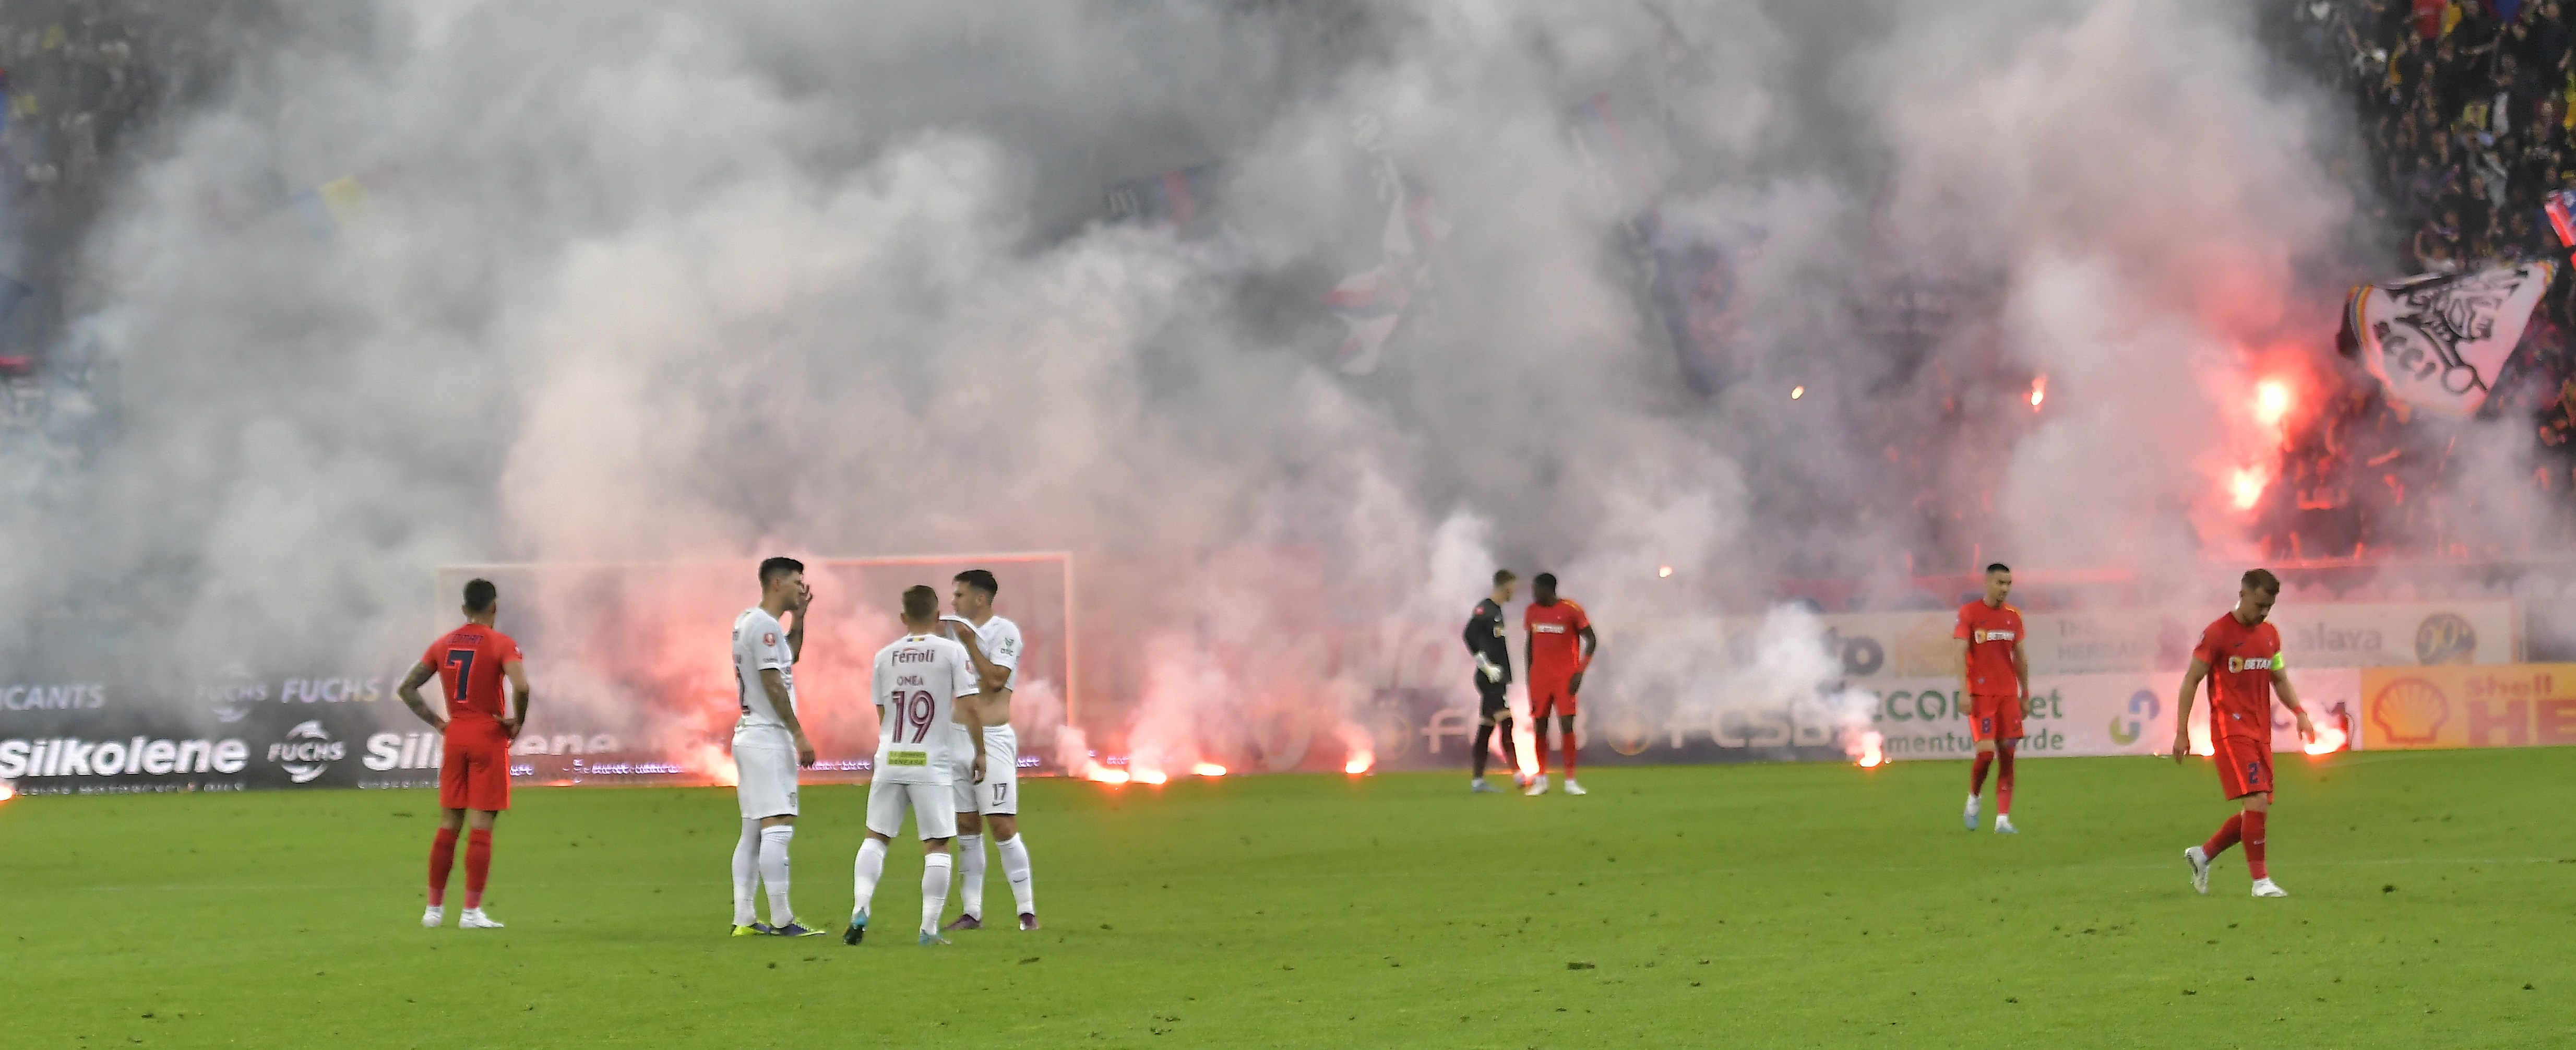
[[1466, 569, 1600, 795]]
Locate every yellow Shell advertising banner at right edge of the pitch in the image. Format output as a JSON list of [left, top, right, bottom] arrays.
[[2362, 664, 2576, 751]]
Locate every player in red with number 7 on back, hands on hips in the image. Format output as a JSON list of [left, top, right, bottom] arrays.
[[394, 579, 528, 929]]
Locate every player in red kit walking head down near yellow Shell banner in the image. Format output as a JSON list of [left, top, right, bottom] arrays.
[[2174, 569, 2316, 896]]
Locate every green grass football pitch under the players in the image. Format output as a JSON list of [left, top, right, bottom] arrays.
[[0, 749, 2576, 1050]]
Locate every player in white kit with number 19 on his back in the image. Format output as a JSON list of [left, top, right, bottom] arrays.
[[840, 587, 984, 945]]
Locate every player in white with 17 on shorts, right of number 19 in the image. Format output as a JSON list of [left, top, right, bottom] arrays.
[[943, 569, 1038, 929]]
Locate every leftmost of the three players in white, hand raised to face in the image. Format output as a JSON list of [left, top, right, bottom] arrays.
[[734, 558, 822, 937]]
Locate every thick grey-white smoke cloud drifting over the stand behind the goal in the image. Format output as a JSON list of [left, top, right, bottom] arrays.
[[0, 0, 2421, 769]]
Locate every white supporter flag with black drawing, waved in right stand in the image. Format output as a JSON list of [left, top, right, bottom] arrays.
[[2336, 260, 2558, 417]]
